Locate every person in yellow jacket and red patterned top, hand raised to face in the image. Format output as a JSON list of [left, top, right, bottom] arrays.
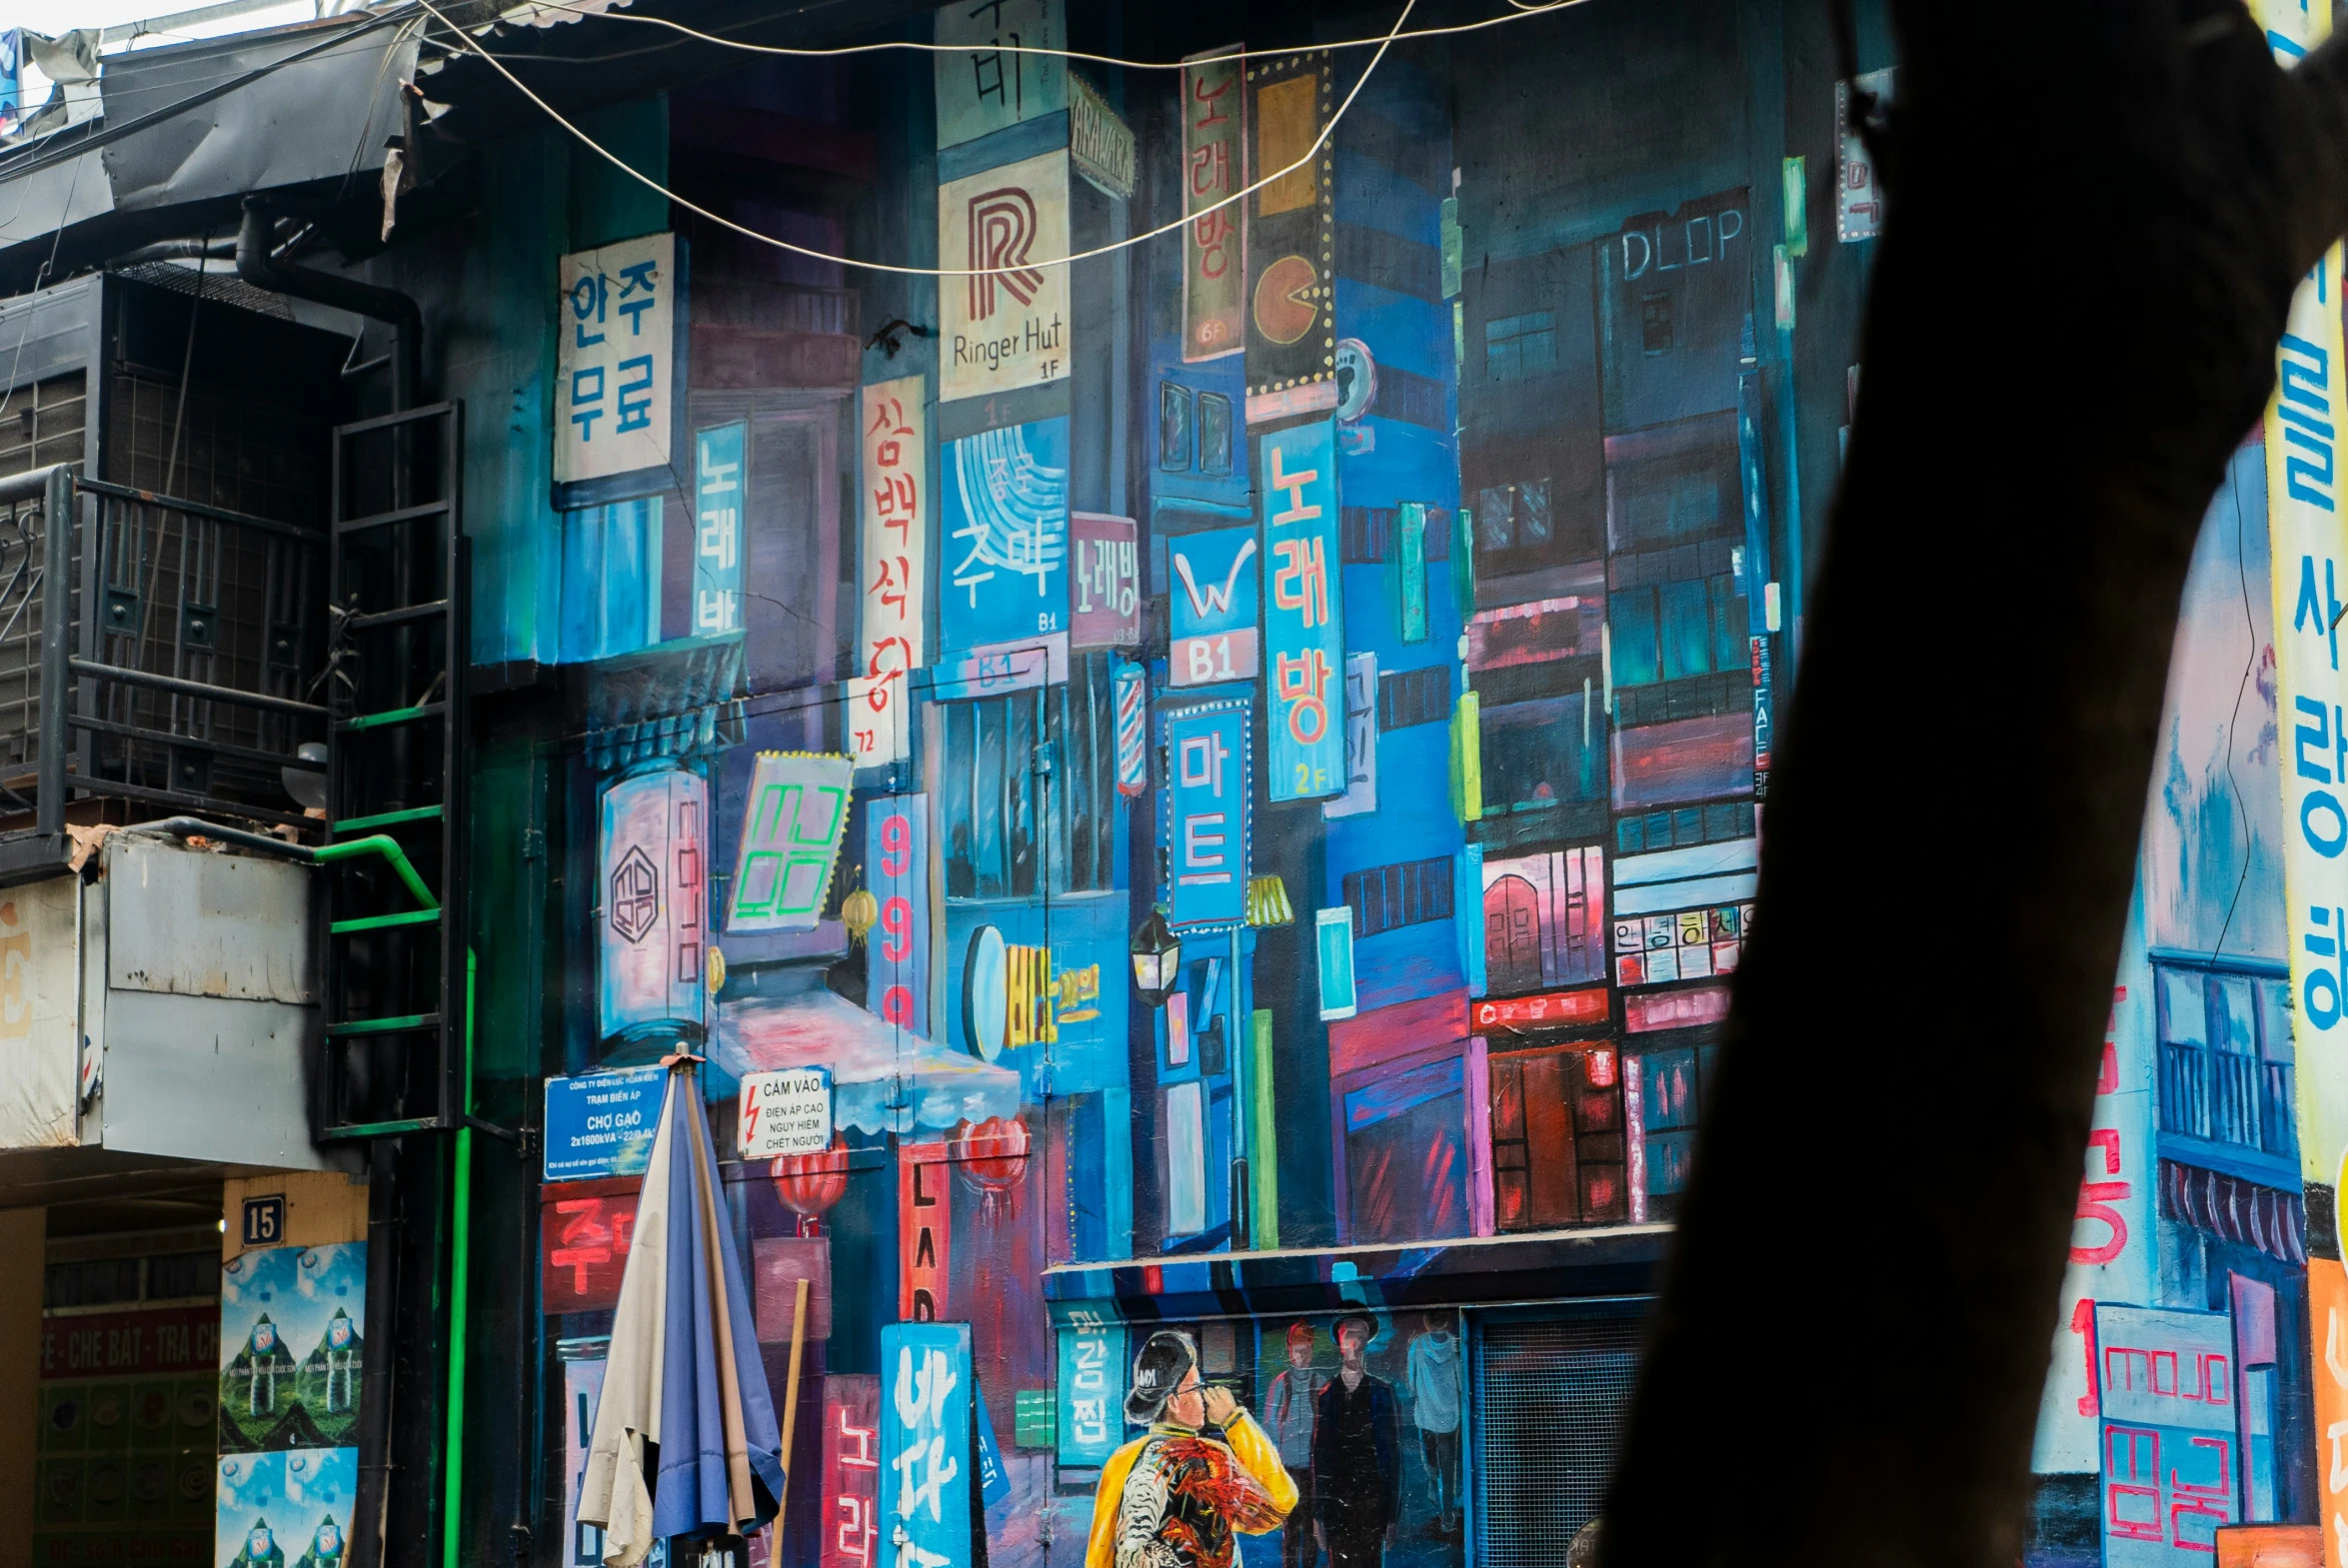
[[1085, 1331, 1296, 1568]]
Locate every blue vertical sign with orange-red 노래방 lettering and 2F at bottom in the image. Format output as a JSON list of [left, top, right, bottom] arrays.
[[1258, 420, 1345, 800]]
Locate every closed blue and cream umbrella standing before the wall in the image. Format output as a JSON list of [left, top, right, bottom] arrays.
[[580, 1056, 782, 1568]]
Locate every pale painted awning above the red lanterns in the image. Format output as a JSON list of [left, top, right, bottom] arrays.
[[707, 969, 1019, 1133]]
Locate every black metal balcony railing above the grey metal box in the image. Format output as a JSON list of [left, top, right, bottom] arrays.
[[0, 465, 329, 868]]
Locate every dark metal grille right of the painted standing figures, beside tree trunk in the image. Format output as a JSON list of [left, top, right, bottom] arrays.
[[1474, 1317, 1641, 1568]]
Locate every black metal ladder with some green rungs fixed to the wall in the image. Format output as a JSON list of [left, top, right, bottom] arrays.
[[315, 404, 472, 1143]]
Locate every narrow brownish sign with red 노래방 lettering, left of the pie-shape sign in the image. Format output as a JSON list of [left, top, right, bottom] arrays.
[[1181, 52, 1246, 364]]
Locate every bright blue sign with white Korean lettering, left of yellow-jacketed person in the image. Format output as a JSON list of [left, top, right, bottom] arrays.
[[879, 1324, 980, 1568]]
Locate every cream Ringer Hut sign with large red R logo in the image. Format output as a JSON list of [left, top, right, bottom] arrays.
[[937, 150, 1069, 402]]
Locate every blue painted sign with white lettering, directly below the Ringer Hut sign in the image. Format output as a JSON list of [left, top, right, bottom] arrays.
[[940, 416, 1069, 651]]
